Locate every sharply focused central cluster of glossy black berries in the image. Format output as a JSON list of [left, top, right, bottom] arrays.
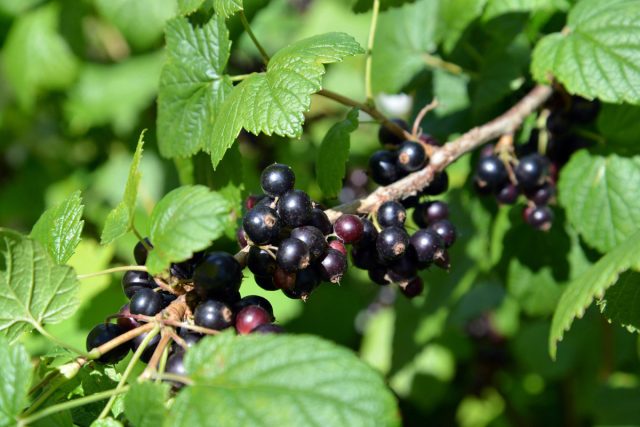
[[238, 163, 347, 300]]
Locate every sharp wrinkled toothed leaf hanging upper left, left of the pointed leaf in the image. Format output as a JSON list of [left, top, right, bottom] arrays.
[[158, 16, 232, 157]]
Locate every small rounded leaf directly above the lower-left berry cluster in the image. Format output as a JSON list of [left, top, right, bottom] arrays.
[[147, 185, 232, 274]]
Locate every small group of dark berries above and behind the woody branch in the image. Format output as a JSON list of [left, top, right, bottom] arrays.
[[369, 119, 449, 196]]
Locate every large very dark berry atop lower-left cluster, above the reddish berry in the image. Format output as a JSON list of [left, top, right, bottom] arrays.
[[193, 252, 242, 299]]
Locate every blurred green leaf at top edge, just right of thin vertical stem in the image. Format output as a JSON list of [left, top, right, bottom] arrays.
[[372, 0, 438, 93]]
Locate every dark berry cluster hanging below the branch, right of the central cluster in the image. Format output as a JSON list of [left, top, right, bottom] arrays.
[[350, 201, 456, 298]]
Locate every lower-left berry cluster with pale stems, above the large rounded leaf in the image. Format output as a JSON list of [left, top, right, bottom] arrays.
[[86, 239, 282, 375]]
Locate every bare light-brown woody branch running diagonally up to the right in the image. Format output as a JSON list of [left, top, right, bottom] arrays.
[[325, 85, 553, 222]]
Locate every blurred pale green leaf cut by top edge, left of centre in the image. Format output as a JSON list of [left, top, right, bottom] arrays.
[[95, 0, 178, 49]]
